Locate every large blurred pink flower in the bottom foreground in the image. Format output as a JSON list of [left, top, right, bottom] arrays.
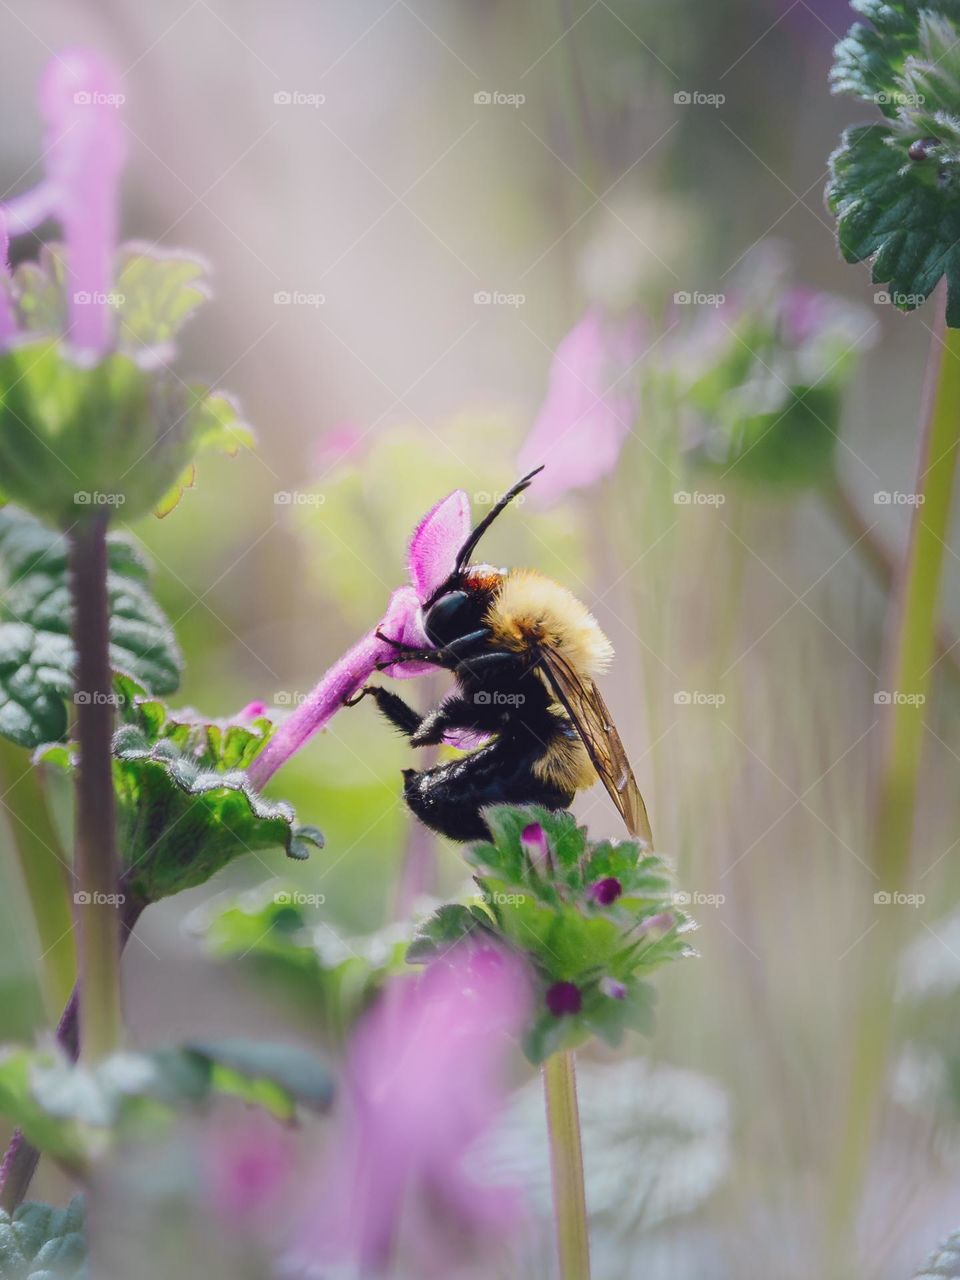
[[298, 945, 530, 1276]]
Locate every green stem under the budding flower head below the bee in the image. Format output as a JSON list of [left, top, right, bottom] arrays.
[[543, 1053, 590, 1280]]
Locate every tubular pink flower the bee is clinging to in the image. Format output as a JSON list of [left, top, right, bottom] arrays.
[[248, 489, 470, 788]]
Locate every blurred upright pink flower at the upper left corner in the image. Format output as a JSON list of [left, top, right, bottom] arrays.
[[6, 49, 125, 356]]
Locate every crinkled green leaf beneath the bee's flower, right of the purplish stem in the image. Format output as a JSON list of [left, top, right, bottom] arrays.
[[40, 677, 323, 904]]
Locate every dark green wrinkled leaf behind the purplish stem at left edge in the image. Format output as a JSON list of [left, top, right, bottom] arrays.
[[0, 507, 183, 748]]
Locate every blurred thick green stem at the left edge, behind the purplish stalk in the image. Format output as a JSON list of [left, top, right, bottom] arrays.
[[0, 737, 76, 1020]]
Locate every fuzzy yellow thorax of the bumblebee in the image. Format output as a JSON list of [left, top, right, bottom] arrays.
[[486, 568, 613, 677]]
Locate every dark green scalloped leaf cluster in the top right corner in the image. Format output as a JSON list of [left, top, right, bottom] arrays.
[[827, 0, 960, 328]]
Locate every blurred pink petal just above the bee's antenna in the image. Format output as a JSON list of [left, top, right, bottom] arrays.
[[518, 307, 641, 502]]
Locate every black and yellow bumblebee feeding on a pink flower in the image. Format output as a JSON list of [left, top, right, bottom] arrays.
[[348, 467, 653, 845]]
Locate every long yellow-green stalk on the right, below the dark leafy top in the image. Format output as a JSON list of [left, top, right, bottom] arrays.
[[829, 304, 960, 1275]]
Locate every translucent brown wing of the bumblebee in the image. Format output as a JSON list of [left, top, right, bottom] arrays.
[[539, 649, 653, 849]]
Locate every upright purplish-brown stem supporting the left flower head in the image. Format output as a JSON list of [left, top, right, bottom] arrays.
[[70, 512, 122, 1061]]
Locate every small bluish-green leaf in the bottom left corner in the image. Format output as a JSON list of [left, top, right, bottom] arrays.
[[0, 1196, 87, 1280]]
